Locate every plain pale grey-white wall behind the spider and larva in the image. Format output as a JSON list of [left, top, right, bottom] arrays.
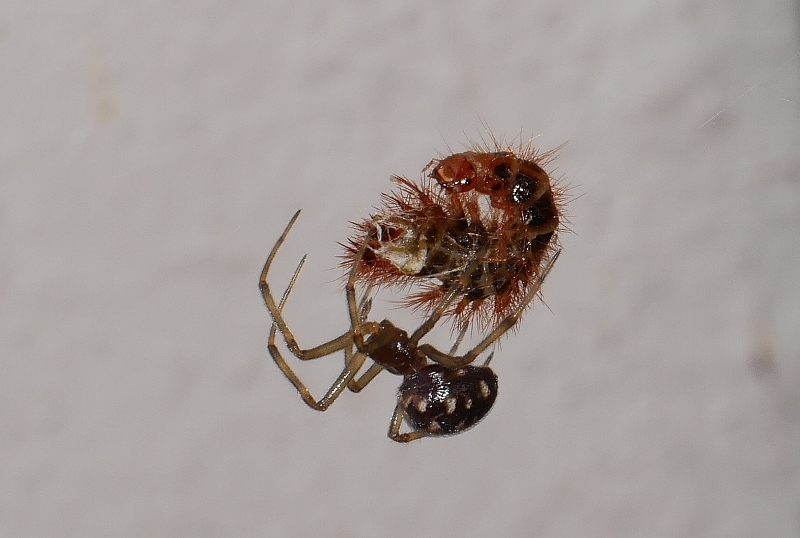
[[0, 0, 800, 537]]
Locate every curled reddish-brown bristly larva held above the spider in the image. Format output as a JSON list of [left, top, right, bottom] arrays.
[[341, 131, 568, 331]]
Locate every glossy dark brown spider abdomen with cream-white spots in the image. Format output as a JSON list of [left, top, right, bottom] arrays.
[[398, 364, 497, 435]]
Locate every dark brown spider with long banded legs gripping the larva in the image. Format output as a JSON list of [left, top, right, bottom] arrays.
[[259, 211, 560, 443]]
